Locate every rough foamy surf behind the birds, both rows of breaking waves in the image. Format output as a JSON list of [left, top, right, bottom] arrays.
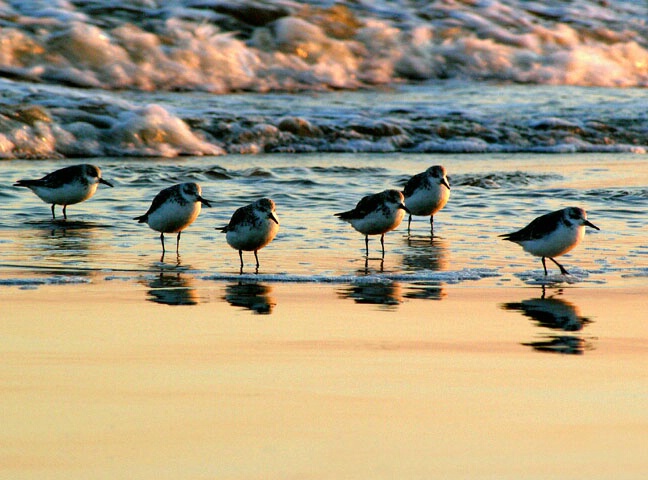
[[0, 0, 648, 159]]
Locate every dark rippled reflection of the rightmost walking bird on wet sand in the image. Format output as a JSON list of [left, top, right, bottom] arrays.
[[501, 287, 593, 355]]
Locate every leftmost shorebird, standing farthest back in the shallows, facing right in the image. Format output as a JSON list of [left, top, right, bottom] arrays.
[[14, 164, 113, 220]]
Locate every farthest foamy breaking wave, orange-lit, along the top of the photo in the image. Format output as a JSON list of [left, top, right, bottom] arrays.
[[0, 0, 648, 93]]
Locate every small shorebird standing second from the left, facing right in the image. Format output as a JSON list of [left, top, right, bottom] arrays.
[[133, 182, 211, 258]]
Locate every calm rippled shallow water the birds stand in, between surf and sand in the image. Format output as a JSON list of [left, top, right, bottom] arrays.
[[0, 154, 648, 286]]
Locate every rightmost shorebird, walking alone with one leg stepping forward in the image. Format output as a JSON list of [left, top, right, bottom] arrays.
[[500, 207, 600, 275]]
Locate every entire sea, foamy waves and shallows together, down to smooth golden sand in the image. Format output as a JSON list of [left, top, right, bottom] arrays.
[[0, 1, 648, 288]]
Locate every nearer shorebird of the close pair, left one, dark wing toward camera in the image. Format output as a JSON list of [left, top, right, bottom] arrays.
[[335, 190, 410, 258]]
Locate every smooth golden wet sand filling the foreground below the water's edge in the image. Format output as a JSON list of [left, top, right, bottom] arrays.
[[0, 277, 648, 479]]
